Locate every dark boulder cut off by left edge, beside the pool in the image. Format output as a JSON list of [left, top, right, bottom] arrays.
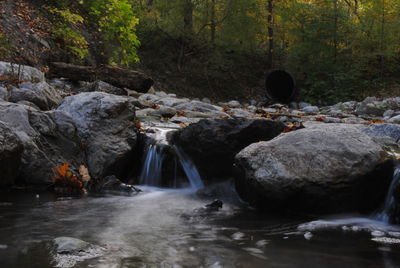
[[0, 122, 23, 186]]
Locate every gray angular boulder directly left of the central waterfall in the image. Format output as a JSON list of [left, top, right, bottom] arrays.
[[58, 92, 137, 178]]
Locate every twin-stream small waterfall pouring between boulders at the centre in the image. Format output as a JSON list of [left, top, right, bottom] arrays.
[[139, 128, 204, 190]]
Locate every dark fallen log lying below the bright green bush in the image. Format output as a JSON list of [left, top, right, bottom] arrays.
[[49, 62, 154, 92]]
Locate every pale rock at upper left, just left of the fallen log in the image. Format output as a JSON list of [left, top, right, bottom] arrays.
[[9, 82, 61, 110]]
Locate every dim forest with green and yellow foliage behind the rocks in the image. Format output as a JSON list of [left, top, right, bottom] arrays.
[[0, 0, 400, 105]]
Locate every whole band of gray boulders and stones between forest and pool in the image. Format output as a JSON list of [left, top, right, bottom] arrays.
[[0, 63, 400, 216]]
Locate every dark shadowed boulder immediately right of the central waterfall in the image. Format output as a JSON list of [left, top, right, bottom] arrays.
[[172, 118, 285, 180]]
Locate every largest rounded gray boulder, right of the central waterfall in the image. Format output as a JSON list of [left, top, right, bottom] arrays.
[[235, 124, 393, 213]]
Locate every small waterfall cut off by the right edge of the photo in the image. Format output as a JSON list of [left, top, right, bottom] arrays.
[[374, 166, 400, 223]]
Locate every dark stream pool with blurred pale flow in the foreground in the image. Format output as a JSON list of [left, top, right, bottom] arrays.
[[0, 188, 400, 268]]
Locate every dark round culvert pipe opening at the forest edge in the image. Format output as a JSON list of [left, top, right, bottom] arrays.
[[265, 70, 296, 103]]
